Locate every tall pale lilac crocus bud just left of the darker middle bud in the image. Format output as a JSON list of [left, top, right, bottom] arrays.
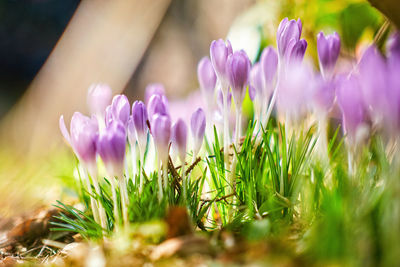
[[210, 39, 232, 86]]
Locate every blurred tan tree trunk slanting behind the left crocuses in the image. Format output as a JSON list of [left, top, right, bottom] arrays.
[[0, 0, 171, 155]]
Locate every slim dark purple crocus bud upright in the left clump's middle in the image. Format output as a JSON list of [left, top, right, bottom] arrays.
[[132, 101, 148, 151]]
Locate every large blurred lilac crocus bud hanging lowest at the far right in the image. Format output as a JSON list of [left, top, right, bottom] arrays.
[[337, 76, 365, 144]]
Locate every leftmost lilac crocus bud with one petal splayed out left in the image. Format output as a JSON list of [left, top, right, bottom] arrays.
[[59, 112, 99, 167]]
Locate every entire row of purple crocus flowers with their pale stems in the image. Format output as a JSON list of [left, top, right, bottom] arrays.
[[60, 18, 400, 232]]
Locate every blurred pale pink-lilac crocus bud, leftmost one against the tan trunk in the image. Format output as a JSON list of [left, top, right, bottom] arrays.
[[87, 84, 112, 117]]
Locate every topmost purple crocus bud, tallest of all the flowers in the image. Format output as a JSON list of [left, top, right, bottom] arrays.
[[276, 18, 302, 59]]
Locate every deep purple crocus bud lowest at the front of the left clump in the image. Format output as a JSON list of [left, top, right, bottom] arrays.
[[97, 120, 126, 176]]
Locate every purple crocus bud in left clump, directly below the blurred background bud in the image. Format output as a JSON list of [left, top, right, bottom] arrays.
[[151, 113, 171, 161]]
